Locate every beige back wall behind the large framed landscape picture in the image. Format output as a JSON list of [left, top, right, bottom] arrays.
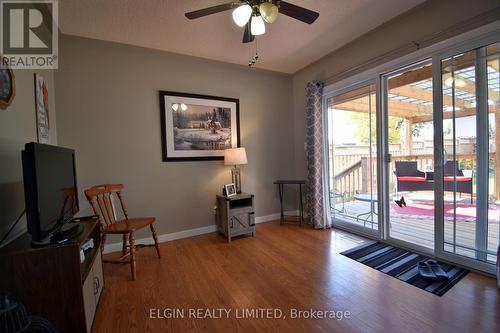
[[55, 36, 295, 236]]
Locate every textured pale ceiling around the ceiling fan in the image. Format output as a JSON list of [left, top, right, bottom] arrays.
[[59, 0, 424, 73]]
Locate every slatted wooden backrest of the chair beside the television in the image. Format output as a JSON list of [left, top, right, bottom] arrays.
[[85, 184, 128, 227]]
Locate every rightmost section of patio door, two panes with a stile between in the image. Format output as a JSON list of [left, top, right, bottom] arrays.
[[436, 44, 500, 270]]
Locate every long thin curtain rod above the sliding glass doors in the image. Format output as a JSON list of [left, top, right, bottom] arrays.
[[324, 6, 500, 85]]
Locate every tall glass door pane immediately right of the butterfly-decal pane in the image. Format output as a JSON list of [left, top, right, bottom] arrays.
[[441, 50, 481, 258]]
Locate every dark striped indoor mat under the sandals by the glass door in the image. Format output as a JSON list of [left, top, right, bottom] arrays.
[[341, 242, 469, 296]]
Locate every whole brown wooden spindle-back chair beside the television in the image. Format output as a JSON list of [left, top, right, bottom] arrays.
[[85, 184, 161, 280]]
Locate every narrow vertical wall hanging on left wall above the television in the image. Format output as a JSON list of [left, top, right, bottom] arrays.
[[34, 73, 50, 143]]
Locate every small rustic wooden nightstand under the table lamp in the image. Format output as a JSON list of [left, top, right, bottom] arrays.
[[216, 193, 255, 242]]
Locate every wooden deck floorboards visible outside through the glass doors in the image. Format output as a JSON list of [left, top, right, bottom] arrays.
[[335, 198, 500, 262]]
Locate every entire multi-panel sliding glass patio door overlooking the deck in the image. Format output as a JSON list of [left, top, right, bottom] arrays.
[[324, 36, 500, 273]]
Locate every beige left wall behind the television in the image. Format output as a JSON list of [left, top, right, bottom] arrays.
[[0, 69, 57, 244]]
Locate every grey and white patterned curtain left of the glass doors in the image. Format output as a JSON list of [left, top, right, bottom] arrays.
[[306, 81, 331, 229]]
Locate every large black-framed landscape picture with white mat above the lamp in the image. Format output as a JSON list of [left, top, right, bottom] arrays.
[[160, 91, 240, 161]]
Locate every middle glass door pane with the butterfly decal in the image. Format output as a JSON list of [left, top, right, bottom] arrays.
[[383, 59, 435, 251]]
